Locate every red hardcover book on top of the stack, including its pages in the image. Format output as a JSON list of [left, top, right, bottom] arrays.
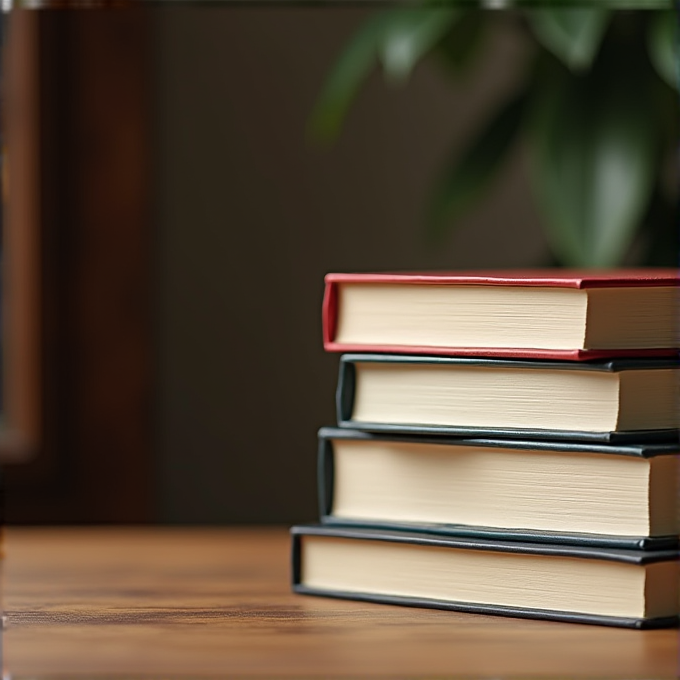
[[323, 268, 680, 361]]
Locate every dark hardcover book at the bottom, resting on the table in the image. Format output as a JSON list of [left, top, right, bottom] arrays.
[[291, 525, 680, 628]]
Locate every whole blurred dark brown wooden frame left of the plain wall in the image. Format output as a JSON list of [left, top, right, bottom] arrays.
[[0, 8, 154, 523]]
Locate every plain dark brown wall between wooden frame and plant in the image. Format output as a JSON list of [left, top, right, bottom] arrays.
[[154, 7, 547, 522]]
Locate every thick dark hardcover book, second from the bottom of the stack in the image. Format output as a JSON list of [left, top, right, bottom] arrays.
[[318, 427, 680, 550]]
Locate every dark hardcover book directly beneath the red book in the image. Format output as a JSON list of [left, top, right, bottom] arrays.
[[337, 354, 680, 442]]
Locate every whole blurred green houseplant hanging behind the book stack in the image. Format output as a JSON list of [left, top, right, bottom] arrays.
[[310, 8, 680, 267]]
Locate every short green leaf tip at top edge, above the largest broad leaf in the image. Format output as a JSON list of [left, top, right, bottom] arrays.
[[529, 7, 610, 71]]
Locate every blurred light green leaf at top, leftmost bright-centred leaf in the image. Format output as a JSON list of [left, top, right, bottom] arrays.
[[380, 7, 458, 83]]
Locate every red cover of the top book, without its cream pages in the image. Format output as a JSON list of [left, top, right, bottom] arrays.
[[322, 268, 680, 361]]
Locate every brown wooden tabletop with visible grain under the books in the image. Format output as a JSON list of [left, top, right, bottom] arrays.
[[4, 528, 679, 680]]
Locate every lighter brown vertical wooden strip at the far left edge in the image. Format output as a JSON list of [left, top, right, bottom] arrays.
[[0, 12, 42, 462]]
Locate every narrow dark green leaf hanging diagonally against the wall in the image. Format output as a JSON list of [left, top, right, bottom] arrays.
[[427, 92, 527, 239]]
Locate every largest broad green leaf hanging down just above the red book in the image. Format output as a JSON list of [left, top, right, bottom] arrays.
[[533, 61, 658, 267]]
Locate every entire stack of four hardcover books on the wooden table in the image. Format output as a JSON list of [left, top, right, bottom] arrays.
[[292, 270, 680, 628]]
